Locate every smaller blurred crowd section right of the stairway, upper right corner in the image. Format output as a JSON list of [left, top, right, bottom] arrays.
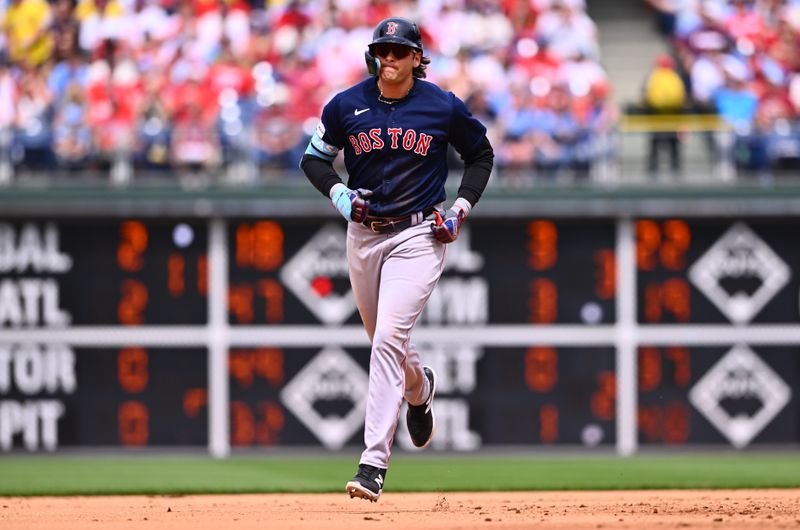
[[646, 0, 800, 174]]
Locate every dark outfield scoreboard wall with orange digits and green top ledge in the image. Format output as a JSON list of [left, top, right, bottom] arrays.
[[0, 184, 800, 456]]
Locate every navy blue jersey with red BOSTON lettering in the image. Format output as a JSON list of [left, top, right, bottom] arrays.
[[306, 77, 486, 217]]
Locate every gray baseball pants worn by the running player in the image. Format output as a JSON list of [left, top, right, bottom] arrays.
[[347, 220, 447, 469]]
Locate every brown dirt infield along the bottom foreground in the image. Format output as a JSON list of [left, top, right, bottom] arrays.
[[0, 490, 800, 530]]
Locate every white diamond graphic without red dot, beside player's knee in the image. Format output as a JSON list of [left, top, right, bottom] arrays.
[[280, 347, 369, 450]]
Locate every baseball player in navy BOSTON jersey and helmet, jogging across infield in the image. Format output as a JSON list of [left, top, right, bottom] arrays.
[[300, 18, 494, 502]]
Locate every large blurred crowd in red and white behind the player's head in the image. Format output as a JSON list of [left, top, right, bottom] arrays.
[[0, 0, 612, 179]]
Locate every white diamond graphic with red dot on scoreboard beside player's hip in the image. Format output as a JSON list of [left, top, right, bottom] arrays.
[[281, 224, 356, 324]]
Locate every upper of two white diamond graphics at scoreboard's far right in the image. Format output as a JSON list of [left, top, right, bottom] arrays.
[[689, 223, 791, 324]]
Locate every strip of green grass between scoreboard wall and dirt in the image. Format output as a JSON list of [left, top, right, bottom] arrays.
[[0, 453, 800, 496]]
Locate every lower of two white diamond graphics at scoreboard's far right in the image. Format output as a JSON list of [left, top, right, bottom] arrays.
[[689, 345, 792, 449]]
